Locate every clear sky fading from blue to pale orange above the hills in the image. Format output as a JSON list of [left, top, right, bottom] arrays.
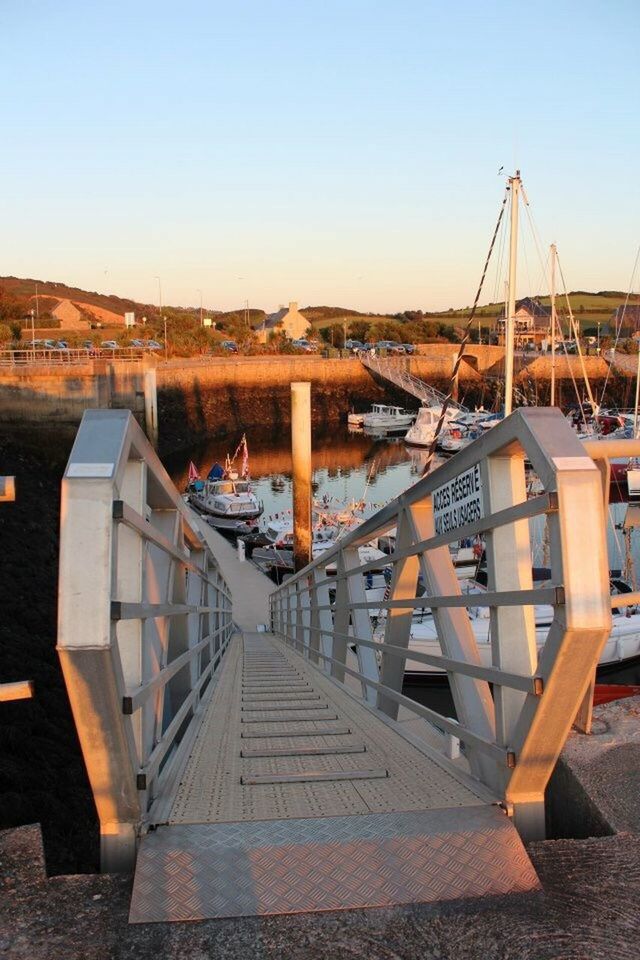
[[0, 0, 640, 312]]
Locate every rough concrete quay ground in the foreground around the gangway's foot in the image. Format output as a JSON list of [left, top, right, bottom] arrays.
[[0, 697, 640, 960]]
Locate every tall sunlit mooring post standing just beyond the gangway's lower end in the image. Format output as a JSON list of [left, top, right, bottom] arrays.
[[291, 382, 311, 571]]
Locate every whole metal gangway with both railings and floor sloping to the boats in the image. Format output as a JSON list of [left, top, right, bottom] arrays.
[[58, 408, 638, 922]]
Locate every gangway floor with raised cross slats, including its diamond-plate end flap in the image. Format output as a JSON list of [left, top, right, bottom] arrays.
[[130, 633, 538, 923]]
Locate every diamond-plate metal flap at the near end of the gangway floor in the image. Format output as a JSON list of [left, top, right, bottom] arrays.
[[129, 806, 539, 923]]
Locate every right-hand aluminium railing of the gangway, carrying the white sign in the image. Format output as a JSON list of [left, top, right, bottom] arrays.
[[271, 408, 612, 838]]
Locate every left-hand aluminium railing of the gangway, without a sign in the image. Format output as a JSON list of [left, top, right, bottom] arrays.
[[57, 410, 233, 871]]
